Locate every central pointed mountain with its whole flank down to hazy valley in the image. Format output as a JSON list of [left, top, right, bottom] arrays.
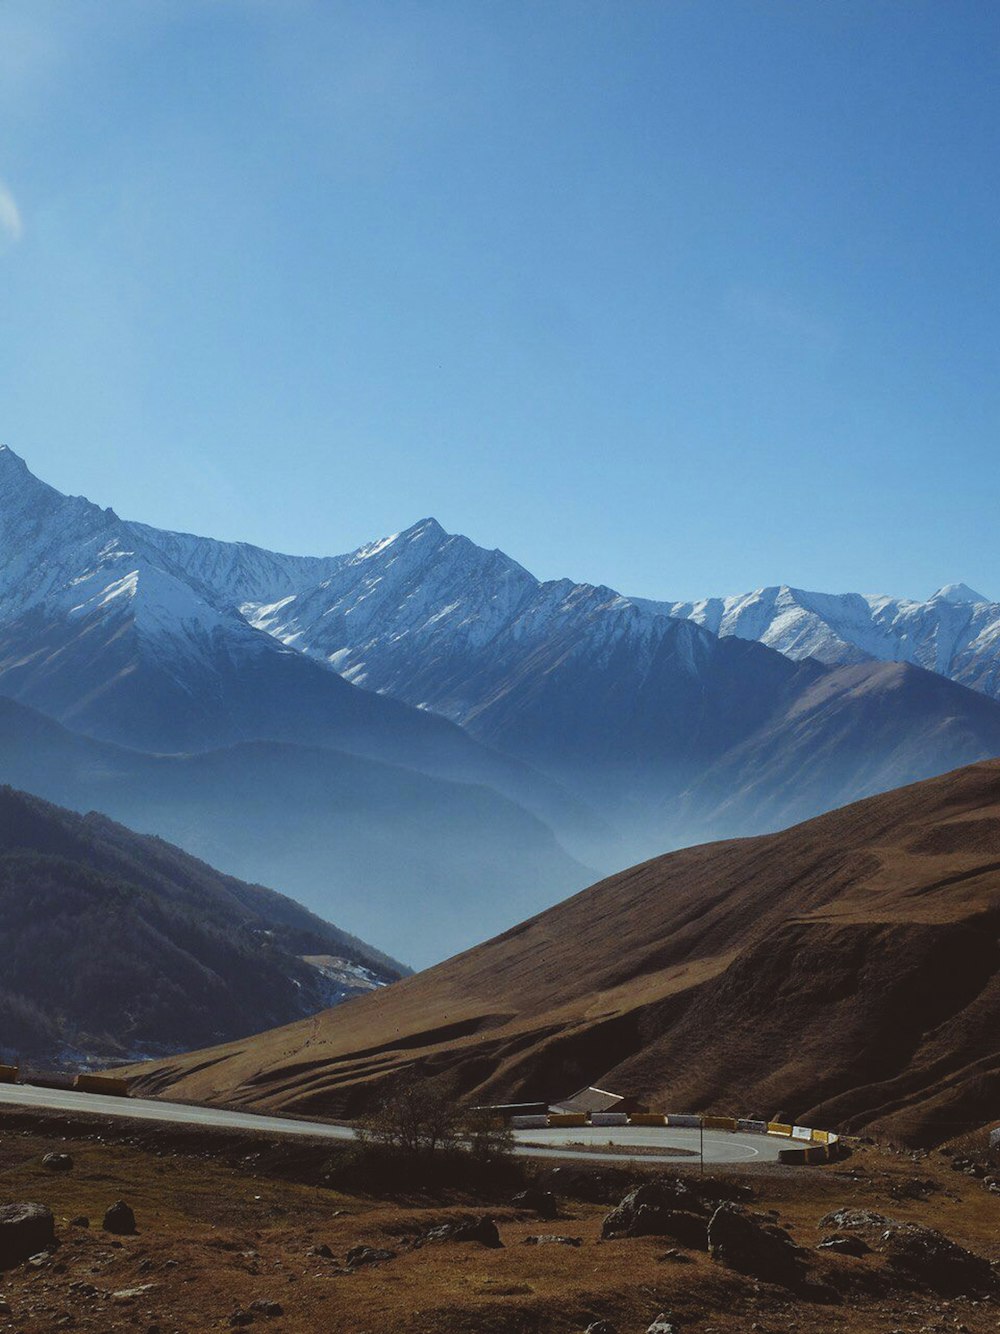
[[221, 519, 1000, 864]]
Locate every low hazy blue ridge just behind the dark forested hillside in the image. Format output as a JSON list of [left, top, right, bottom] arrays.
[[0, 699, 592, 964]]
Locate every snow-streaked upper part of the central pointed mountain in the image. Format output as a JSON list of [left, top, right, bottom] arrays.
[[243, 519, 715, 722]]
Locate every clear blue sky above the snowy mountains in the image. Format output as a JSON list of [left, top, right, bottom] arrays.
[[0, 0, 1000, 598]]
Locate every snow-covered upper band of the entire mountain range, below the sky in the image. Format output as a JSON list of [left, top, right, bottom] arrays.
[[7, 446, 1000, 722]]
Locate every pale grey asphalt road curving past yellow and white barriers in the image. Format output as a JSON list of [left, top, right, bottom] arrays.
[[0, 1085, 788, 1166]]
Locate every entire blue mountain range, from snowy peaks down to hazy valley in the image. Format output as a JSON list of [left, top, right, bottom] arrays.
[[0, 448, 1000, 964]]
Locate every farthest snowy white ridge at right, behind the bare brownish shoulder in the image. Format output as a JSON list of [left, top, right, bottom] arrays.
[[666, 584, 1000, 699]]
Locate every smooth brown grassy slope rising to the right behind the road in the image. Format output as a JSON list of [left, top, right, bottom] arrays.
[[132, 762, 1000, 1139]]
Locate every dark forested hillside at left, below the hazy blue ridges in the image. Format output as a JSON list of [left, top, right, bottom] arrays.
[[0, 787, 405, 1063]]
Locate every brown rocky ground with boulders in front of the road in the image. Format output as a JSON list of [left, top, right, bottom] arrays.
[[0, 1113, 1000, 1334]]
